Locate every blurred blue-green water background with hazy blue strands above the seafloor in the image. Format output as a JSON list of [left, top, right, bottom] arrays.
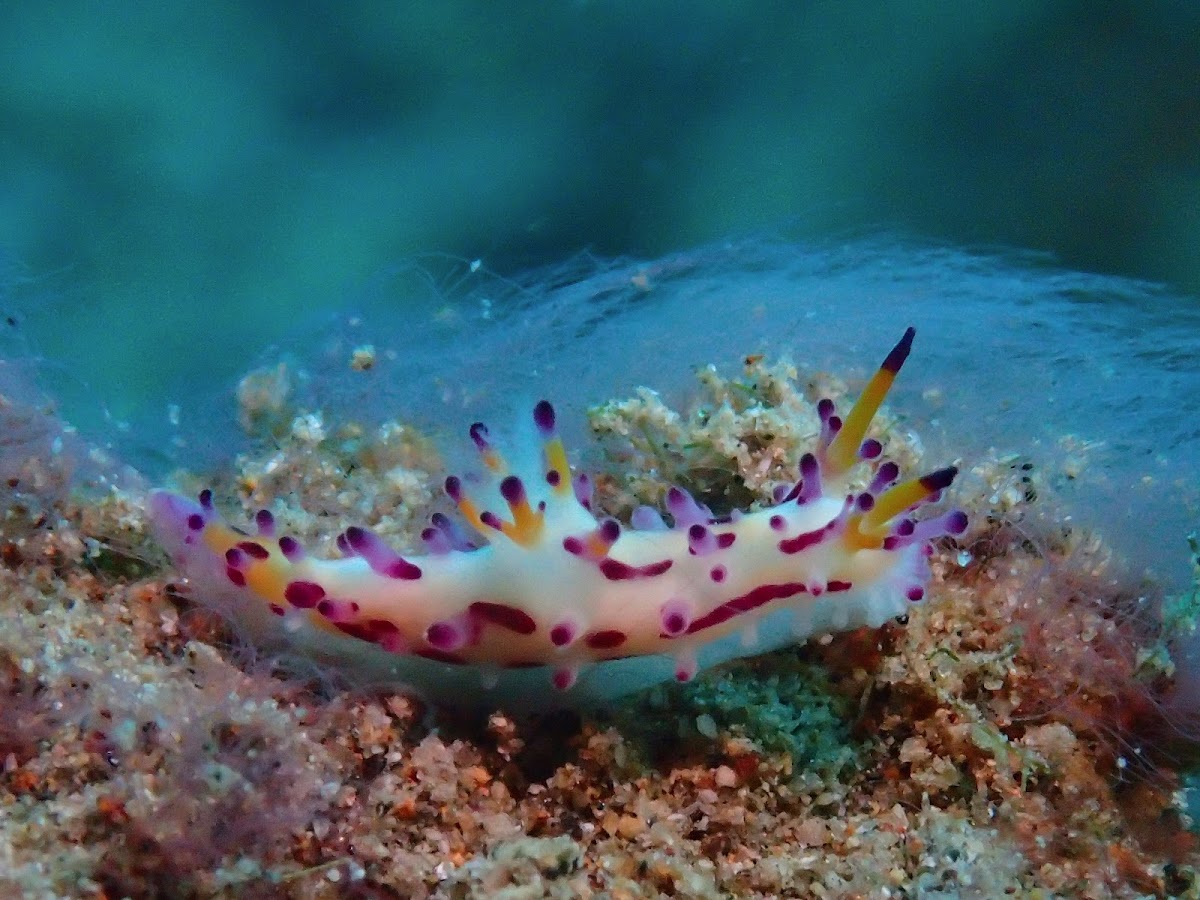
[[0, 7, 1200, 585]]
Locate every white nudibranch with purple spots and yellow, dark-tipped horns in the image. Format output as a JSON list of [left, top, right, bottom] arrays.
[[150, 328, 966, 707]]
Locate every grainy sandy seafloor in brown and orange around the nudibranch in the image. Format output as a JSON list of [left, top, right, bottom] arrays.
[[0, 348, 1200, 900]]
